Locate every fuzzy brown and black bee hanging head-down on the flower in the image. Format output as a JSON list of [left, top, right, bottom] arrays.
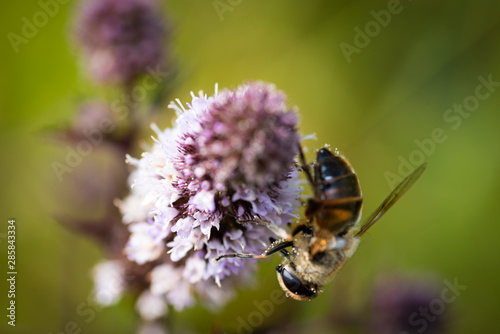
[[215, 147, 426, 300]]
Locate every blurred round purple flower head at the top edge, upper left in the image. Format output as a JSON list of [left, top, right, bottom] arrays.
[[77, 0, 165, 83]]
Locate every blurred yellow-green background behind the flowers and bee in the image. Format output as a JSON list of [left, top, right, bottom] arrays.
[[0, 0, 500, 334]]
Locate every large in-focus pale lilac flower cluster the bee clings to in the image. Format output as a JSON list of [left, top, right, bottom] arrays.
[[113, 82, 301, 318]]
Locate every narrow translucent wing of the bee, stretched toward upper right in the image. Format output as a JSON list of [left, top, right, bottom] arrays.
[[356, 163, 427, 237]]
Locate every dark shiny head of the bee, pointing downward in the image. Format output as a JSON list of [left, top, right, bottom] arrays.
[[276, 264, 318, 300]]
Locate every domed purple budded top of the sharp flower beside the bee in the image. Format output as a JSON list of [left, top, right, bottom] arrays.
[[176, 83, 299, 193]]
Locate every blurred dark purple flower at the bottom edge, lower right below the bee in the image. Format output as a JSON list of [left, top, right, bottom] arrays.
[[368, 275, 447, 334]]
